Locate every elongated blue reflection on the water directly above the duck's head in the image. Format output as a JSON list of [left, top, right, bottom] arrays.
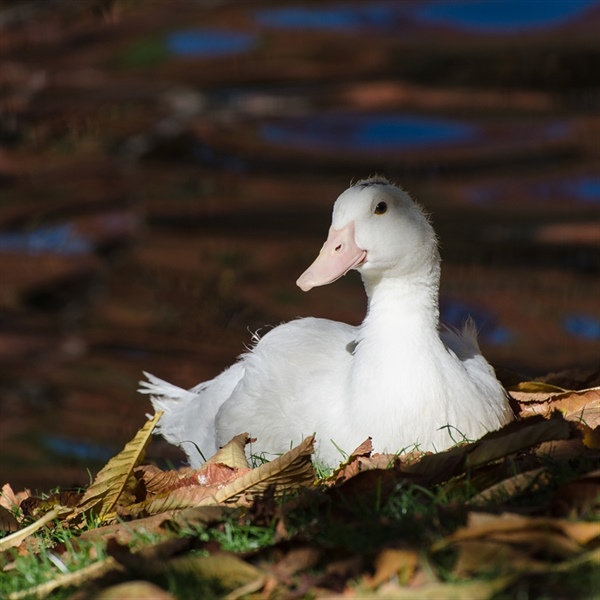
[[260, 113, 478, 151]]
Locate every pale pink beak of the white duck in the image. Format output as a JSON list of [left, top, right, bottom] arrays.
[[296, 221, 367, 292]]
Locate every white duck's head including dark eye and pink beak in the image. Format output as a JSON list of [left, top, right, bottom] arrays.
[[296, 177, 439, 292]]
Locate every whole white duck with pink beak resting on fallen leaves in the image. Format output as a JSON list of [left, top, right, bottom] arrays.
[[140, 177, 513, 467]]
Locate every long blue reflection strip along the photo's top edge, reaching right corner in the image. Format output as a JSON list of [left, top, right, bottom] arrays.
[[255, 0, 599, 34]]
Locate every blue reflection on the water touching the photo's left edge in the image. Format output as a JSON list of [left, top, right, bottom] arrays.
[[0, 224, 93, 255]]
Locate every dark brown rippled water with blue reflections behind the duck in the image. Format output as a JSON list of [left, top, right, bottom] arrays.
[[0, 0, 600, 491]]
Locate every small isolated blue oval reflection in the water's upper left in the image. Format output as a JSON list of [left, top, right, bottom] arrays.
[[165, 29, 256, 57]]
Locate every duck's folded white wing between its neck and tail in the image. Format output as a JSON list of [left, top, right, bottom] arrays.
[[216, 318, 356, 454]]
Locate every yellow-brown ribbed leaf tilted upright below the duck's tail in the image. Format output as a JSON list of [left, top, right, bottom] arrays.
[[72, 412, 162, 521]]
